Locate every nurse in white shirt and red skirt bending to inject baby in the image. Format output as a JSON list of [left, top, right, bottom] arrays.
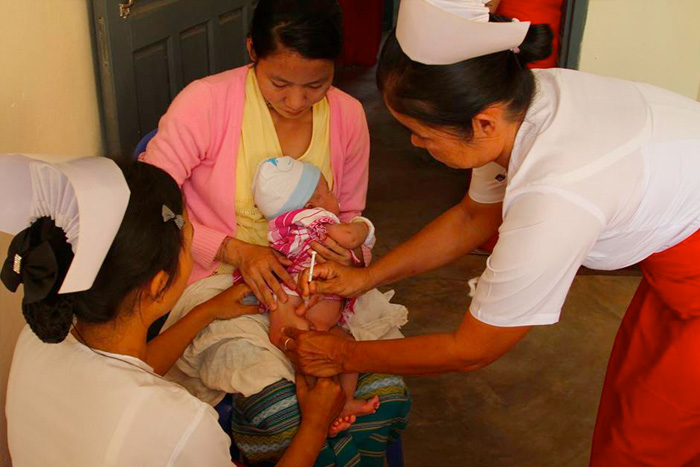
[[287, 0, 700, 466]]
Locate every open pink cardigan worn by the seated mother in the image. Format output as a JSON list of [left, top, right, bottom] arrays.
[[140, 66, 369, 284]]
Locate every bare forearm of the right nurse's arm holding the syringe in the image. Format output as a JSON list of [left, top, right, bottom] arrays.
[[369, 197, 502, 287]]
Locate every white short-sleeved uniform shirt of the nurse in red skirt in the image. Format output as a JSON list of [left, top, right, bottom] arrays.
[[469, 69, 700, 326]]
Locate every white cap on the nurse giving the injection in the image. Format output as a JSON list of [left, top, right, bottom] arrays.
[[396, 0, 530, 65]]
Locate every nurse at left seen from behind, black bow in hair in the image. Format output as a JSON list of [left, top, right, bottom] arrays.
[[0, 155, 344, 467]]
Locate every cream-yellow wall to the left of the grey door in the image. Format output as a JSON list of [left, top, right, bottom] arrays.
[[0, 0, 102, 467]]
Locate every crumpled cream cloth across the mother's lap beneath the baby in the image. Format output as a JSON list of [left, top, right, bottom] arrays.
[[163, 274, 408, 405]]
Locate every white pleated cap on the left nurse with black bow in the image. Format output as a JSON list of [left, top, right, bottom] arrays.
[[0, 154, 130, 294]]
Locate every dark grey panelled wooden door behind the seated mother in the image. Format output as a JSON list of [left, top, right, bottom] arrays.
[[92, 0, 253, 158]]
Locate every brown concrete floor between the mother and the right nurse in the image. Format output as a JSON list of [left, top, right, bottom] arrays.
[[338, 68, 639, 467]]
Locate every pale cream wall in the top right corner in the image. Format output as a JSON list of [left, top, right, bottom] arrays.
[[580, 0, 700, 100]]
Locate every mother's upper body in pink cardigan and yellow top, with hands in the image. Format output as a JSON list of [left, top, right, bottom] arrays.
[[142, 0, 369, 309]]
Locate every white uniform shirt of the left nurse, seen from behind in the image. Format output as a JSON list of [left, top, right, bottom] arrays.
[[6, 326, 233, 467]]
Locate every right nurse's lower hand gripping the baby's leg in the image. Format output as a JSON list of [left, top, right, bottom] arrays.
[[284, 328, 355, 378]]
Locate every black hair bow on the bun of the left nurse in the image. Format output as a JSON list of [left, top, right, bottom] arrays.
[[0, 229, 58, 304]]
